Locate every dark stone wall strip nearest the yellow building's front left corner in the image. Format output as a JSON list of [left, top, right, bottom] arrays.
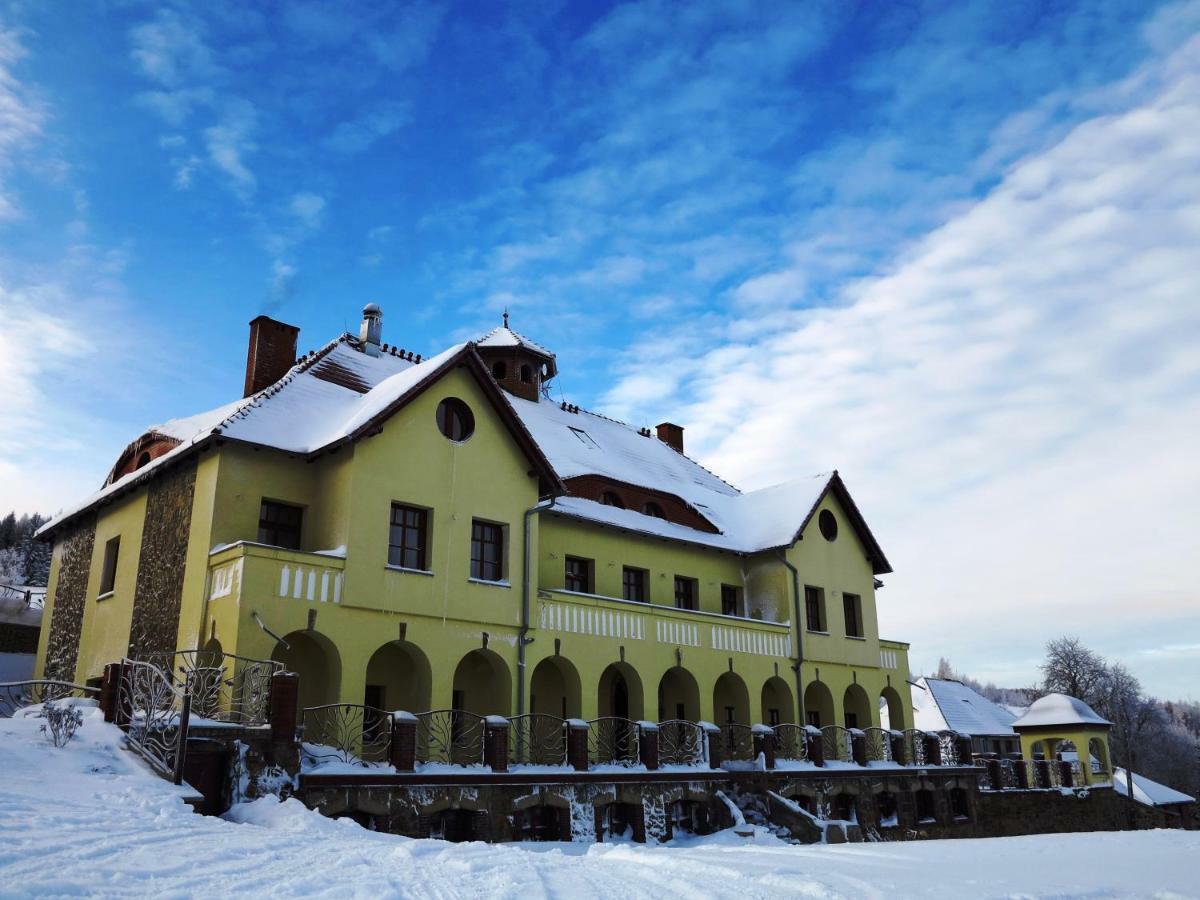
[[130, 462, 196, 658]]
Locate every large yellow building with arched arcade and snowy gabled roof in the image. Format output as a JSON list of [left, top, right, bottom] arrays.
[[37, 305, 912, 728]]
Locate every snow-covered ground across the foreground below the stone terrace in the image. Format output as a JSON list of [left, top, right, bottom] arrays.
[[0, 710, 1200, 900]]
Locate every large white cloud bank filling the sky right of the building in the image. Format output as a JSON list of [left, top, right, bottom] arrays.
[[608, 38, 1200, 689]]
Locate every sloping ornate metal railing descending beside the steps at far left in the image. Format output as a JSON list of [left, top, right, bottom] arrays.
[[116, 659, 191, 785]]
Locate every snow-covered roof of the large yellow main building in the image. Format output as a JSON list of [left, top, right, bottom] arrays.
[[41, 324, 890, 572]]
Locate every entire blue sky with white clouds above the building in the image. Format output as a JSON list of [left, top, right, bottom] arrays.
[[0, 1, 1200, 698]]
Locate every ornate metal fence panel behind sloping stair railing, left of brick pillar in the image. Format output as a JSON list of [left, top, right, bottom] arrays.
[[142, 650, 283, 725]]
